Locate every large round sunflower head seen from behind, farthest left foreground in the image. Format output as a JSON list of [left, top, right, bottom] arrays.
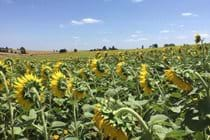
[[14, 74, 44, 110]]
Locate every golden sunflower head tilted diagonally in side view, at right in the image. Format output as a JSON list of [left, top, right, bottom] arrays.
[[164, 69, 192, 91]]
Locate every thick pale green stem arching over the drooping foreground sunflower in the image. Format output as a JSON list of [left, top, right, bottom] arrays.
[[113, 107, 152, 139]]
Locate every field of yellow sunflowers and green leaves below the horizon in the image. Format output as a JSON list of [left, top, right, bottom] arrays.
[[0, 38, 210, 140]]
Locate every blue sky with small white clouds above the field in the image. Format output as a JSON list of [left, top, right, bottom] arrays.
[[0, 0, 210, 50]]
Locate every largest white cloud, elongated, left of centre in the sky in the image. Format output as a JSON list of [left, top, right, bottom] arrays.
[[71, 18, 102, 25]]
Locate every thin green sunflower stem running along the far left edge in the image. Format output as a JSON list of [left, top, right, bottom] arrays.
[[0, 71, 15, 140]]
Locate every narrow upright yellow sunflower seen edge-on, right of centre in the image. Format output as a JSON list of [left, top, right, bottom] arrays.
[[139, 64, 152, 93]]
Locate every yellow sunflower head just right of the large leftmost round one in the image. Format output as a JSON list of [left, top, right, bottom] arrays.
[[50, 71, 72, 98]]
